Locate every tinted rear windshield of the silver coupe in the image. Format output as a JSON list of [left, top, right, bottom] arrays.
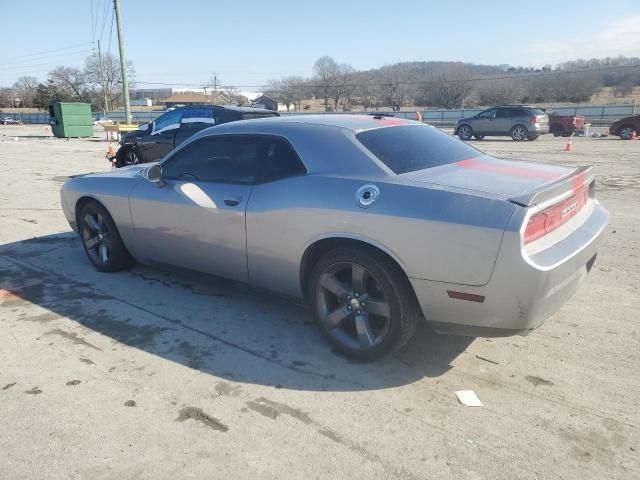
[[356, 125, 482, 175]]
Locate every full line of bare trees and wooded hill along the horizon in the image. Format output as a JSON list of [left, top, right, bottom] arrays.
[[0, 53, 640, 111]]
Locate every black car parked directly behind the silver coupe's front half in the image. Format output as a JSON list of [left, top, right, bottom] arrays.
[[109, 105, 279, 168]]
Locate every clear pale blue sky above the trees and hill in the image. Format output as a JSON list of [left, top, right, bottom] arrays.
[[0, 0, 640, 90]]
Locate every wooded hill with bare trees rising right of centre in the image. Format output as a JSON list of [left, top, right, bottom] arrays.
[[265, 56, 640, 111]]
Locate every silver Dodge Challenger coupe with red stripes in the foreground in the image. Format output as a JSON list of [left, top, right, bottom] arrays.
[[61, 115, 609, 360]]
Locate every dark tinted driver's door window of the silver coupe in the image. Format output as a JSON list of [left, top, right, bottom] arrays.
[[162, 136, 260, 184]]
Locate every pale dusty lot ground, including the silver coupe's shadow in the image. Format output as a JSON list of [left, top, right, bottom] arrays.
[[0, 126, 640, 480]]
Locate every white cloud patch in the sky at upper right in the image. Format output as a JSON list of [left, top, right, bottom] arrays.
[[523, 15, 640, 66]]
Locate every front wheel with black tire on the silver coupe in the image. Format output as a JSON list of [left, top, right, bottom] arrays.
[[77, 201, 134, 272]]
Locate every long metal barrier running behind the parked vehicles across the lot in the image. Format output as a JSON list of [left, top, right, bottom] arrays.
[[0, 105, 639, 127]]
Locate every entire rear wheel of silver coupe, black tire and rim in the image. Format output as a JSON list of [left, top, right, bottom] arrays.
[[308, 247, 421, 361]]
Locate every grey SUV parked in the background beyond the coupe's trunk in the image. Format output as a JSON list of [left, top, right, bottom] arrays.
[[455, 105, 549, 141]]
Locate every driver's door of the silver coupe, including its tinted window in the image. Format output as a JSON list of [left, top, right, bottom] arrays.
[[129, 135, 260, 282]]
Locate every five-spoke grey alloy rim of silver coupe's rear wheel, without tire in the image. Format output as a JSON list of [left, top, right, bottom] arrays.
[[316, 262, 391, 350]]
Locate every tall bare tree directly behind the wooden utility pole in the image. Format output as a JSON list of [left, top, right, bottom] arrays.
[[84, 53, 135, 110]]
